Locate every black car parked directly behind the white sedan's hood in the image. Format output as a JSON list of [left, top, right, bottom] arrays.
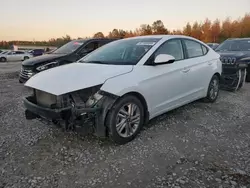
[[19, 39, 117, 83]]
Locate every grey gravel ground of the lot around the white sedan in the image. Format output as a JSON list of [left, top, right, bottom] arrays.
[[0, 70, 250, 188]]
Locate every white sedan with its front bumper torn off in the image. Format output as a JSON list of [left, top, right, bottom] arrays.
[[24, 35, 222, 144]]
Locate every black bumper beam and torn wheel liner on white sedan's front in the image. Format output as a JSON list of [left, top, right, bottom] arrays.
[[23, 93, 115, 137]]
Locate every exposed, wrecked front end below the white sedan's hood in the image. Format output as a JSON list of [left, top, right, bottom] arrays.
[[24, 85, 116, 136]]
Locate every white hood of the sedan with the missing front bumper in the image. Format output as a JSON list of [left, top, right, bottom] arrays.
[[25, 63, 133, 96]]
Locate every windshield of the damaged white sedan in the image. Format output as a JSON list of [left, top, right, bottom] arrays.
[[79, 38, 160, 65]]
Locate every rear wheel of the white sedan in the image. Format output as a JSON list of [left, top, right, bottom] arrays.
[[204, 75, 220, 103]]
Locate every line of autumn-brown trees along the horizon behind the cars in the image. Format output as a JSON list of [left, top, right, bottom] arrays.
[[0, 13, 250, 49]]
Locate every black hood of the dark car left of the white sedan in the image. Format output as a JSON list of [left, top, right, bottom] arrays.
[[22, 54, 67, 66]]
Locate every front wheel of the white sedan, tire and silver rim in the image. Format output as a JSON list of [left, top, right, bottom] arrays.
[[105, 95, 145, 145]]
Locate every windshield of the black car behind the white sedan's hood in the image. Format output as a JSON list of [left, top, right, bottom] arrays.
[[53, 40, 85, 54]]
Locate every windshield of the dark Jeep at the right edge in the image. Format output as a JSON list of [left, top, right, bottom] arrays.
[[216, 40, 250, 51]]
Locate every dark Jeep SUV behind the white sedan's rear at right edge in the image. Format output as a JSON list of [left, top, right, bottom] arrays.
[[215, 38, 250, 90]]
